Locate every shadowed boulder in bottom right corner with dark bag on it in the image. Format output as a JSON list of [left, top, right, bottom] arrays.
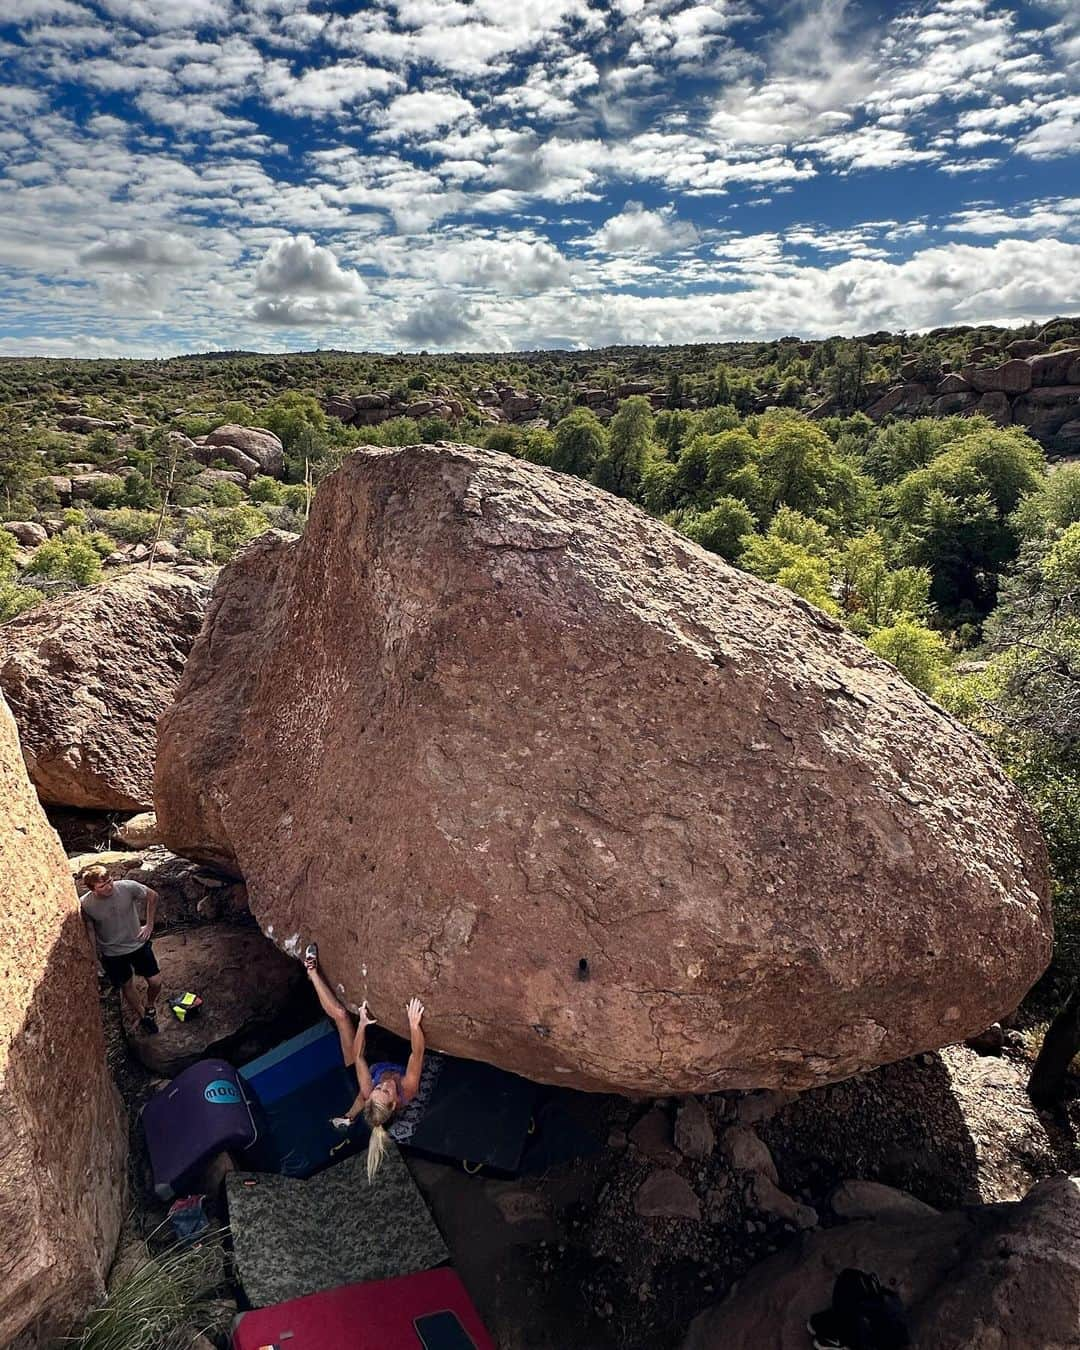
[[683, 1176, 1080, 1350]]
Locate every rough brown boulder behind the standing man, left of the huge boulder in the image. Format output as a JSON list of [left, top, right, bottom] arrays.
[[0, 570, 209, 811]]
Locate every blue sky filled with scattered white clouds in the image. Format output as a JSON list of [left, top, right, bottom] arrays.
[[0, 0, 1080, 356]]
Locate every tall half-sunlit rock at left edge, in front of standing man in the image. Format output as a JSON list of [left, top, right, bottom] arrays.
[[0, 698, 127, 1346]]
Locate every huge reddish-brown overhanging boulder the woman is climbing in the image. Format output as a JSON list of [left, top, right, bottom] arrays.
[[155, 444, 1050, 1096]]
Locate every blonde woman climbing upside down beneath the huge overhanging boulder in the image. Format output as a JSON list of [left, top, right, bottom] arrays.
[[304, 942, 424, 1183]]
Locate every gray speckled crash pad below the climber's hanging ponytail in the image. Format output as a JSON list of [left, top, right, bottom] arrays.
[[225, 1145, 450, 1308]]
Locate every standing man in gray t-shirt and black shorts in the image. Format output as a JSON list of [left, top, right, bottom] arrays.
[[78, 867, 161, 1035]]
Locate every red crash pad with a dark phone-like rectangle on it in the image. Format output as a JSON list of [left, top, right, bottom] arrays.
[[232, 1266, 495, 1350]]
